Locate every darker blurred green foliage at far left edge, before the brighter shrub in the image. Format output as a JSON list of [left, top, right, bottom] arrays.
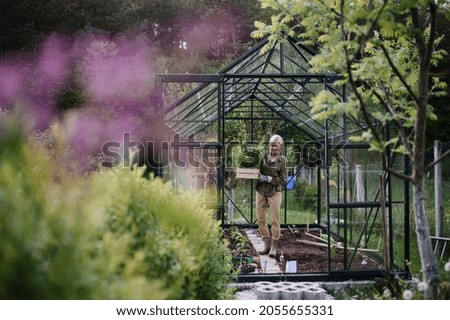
[[0, 124, 142, 299]]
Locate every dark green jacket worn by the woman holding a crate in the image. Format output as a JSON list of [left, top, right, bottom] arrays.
[[256, 154, 287, 197]]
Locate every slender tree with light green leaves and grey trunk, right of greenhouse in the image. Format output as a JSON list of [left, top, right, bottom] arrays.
[[253, 0, 449, 299]]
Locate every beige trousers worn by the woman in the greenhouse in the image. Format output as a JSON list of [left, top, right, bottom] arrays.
[[256, 192, 281, 240]]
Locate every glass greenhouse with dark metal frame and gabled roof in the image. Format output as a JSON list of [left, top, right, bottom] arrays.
[[156, 39, 410, 282]]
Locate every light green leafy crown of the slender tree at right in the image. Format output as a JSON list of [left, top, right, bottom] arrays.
[[253, 0, 447, 153]]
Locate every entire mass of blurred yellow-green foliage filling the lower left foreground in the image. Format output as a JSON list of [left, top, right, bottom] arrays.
[[0, 123, 231, 299]]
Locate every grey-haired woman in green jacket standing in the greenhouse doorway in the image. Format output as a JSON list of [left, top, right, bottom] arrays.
[[256, 134, 287, 257]]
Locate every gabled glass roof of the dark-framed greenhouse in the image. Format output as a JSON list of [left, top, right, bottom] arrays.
[[161, 38, 354, 140]]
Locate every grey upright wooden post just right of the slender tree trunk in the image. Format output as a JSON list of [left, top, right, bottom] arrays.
[[434, 140, 444, 237]]
